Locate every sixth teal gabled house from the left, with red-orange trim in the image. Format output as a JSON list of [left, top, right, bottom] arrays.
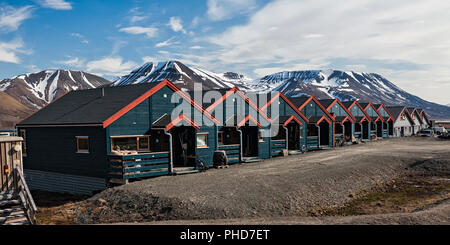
[[342, 100, 371, 141]]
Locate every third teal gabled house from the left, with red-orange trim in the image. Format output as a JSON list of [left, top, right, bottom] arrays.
[[256, 92, 309, 156]]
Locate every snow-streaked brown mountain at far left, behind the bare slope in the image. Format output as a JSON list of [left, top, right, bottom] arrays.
[[0, 70, 110, 110]]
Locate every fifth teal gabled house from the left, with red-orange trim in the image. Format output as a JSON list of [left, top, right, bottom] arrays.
[[319, 98, 356, 145]]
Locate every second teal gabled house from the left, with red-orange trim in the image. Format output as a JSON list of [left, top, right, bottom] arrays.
[[197, 87, 272, 163]]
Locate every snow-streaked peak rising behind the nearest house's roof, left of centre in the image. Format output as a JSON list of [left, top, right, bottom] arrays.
[[112, 61, 251, 90]]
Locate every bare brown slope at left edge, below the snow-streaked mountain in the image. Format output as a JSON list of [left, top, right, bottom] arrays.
[[0, 91, 33, 128]]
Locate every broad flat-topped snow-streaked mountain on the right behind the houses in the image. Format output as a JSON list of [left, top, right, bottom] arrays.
[[251, 70, 450, 118]]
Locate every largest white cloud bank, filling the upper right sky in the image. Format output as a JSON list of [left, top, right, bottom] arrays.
[[209, 0, 450, 103]]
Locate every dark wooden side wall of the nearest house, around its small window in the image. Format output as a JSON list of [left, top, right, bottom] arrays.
[[19, 127, 108, 178]]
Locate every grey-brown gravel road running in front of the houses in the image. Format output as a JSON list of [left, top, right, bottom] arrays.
[[77, 137, 450, 223]]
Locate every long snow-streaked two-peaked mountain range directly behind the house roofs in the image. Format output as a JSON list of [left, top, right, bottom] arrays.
[[112, 61, 450, 118]]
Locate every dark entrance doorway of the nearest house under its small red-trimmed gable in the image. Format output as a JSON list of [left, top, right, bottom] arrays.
[[170, 126, 196, 167]]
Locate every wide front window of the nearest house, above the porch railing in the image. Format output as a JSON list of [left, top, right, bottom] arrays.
[[111, 136, 150, 151]]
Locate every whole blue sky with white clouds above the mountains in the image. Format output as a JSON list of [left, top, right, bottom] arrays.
[[0, 0, 450, 104]]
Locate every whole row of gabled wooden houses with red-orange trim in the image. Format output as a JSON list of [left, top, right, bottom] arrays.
[[16, 80, 429, 194]]
